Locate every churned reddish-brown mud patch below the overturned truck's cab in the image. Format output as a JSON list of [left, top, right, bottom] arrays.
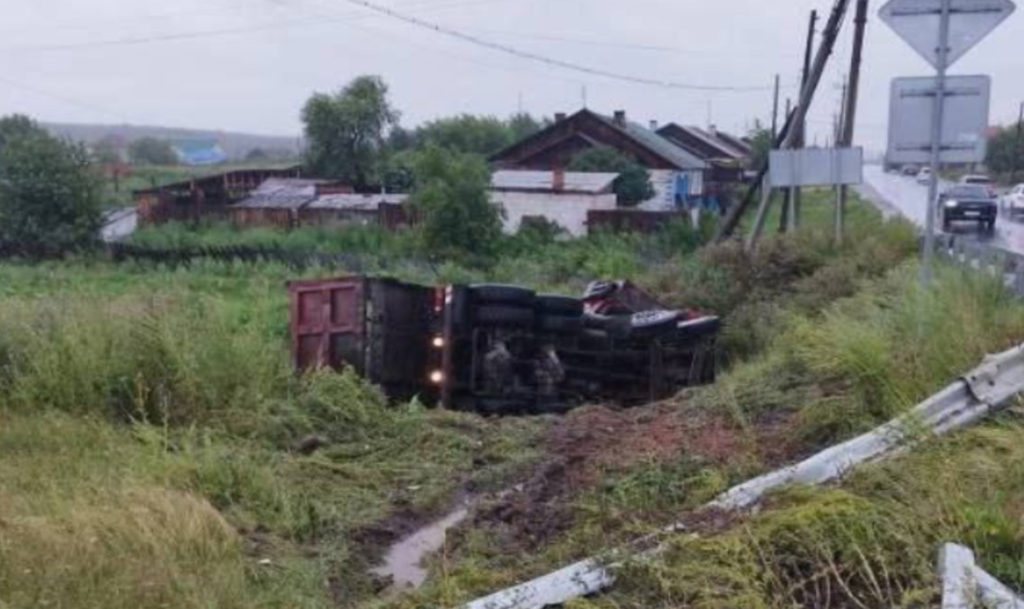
[[469, 402, 802, 552]]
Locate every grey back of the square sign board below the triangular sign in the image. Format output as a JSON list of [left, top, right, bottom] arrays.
[[886, 76, 992, 165]]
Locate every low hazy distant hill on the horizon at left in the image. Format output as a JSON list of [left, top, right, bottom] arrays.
[[43, 123, 302, 160]]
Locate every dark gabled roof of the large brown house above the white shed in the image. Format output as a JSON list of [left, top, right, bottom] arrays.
[[490, 108, 709, 171]]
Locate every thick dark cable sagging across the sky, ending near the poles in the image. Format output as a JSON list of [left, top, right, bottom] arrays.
[[335, 0, 772, 92]]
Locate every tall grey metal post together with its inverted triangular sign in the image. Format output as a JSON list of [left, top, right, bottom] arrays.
[[880, 0, 1016, 284]]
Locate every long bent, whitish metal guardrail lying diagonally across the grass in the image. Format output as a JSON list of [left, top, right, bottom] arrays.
[[463, 345, 1024, 609]]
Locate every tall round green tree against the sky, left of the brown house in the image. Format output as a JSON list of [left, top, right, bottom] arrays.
[[302, 76, 398, 189]]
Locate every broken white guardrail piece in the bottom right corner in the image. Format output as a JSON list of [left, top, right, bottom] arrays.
[[939, 543, 1024, 609]]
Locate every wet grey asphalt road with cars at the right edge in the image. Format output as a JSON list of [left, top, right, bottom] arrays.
[[861, 165, 1024, 254]]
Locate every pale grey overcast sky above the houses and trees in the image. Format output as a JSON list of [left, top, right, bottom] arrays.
[[0, 0, 1024, 149]]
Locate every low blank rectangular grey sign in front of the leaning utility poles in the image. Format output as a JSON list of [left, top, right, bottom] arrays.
[[768, 147, 864, 188]]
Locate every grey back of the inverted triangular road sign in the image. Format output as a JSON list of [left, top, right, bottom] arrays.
[[880, 0, 1016, 68]]
